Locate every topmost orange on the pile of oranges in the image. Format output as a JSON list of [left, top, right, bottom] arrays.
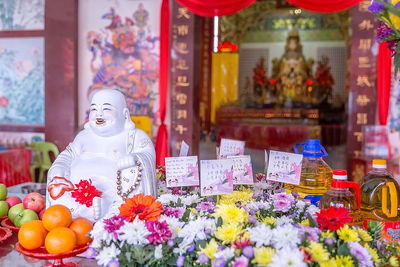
[[42, 205, 72, 231]]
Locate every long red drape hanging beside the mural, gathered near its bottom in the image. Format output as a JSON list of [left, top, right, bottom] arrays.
[[156, 0, 169, 166]]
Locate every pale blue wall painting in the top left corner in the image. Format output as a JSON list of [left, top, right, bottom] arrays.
[[0, 0, 44, 31]]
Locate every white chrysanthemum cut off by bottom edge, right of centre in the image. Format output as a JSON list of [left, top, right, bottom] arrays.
[[268, 248, 307, 267]]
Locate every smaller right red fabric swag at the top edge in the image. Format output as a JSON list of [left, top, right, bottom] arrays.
[[286, 0, 362, 13]]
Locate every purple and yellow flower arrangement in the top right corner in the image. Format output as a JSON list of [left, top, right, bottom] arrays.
[[368, 0, 400, 73]]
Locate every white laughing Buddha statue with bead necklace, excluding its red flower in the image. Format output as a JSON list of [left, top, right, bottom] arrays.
[[46, 89, 157, 222]]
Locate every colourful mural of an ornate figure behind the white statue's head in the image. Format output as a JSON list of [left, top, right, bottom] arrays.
[[80, 1, 160, 132]]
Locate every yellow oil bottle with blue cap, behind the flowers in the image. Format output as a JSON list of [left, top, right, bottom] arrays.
[[286, 139, 332, 205]]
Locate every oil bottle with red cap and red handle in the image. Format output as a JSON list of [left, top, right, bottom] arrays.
[[319, 170, 362, 225]]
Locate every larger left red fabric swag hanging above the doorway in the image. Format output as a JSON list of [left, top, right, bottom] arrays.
[[176, 0, 255, 17]]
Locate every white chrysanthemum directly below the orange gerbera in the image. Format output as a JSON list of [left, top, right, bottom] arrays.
[[118, 217, 150, 245]]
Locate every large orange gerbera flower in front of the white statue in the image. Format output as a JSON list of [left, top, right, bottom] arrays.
[[119, 194, 163, 222]]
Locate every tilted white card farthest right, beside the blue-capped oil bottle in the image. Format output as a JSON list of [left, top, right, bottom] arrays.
[[266, 150, 303, 185]]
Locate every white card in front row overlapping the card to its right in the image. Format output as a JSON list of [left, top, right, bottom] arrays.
[[200, 159, 233, 196]]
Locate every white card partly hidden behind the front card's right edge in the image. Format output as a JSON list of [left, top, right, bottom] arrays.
[[228, 155, 254, 185]]
